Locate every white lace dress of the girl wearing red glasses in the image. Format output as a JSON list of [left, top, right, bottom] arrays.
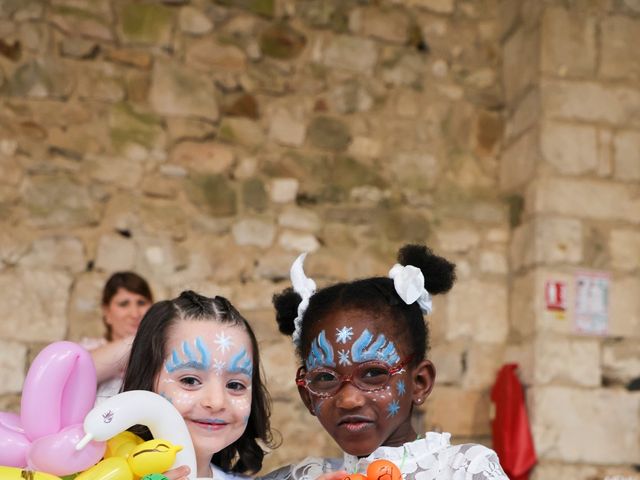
[[259, 432, 509, 480]]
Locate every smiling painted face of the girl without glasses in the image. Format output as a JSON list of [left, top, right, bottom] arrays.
[[155, 320, 253, 470]]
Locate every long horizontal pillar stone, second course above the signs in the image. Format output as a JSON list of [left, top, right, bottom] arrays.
[[527, 178, 640, 224]]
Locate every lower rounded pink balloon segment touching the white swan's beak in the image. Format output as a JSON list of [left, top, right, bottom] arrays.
[[27, 423, 107, 477]]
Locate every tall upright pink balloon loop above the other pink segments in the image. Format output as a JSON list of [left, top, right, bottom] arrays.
[[20, 342, 97, 441]]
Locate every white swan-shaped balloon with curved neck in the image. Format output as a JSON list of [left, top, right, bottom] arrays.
[[76, 390, 198, 480]]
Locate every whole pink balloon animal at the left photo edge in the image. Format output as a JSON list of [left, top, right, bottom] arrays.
[[0, 342, 105, 476]]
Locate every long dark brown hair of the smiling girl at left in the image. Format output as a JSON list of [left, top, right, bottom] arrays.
[[122, 290, 272, 473]]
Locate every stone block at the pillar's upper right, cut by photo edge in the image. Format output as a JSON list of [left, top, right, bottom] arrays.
[[600, 15, 640, 80]]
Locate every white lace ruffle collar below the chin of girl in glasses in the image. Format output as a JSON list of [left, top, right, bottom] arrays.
[[343, 432, 451, 473]]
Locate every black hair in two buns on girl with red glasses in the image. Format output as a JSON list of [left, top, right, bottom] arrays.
[[273, 245, 455, 365]]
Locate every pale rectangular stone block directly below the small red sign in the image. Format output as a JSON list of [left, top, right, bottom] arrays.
[[534, 336, 601, 387]]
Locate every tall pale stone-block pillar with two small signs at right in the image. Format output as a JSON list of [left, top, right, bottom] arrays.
[[501, 0, 640, 480]]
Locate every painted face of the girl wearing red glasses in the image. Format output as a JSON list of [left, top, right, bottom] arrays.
[[303, 309, 416, 456]]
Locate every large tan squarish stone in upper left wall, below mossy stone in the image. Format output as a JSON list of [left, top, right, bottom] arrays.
[[149, 59, 219, 120]]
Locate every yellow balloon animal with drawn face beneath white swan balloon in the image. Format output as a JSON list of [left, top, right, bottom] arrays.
[[75, 439, 182, 480]]
